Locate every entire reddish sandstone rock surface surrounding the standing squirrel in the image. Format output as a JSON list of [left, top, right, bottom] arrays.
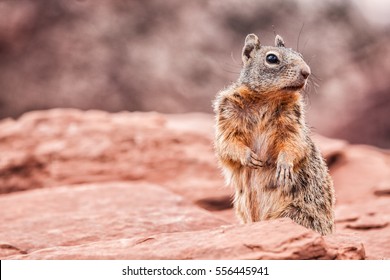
[[0, 109, 390, 259]]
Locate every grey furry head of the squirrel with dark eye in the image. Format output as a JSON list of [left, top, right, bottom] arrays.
[[239, 34, 310, 93]]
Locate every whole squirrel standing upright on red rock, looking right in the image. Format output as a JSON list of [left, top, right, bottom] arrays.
[[213, 34, 335, 235]]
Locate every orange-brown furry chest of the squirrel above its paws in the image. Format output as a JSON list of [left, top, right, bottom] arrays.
[[219, 86, 304, 168]]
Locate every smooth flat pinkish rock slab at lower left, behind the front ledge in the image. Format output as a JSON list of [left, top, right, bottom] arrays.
[[0, 182, 226, 255]]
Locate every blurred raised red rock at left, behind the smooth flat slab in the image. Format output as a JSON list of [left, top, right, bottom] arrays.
[[0, 109, 231, 201]]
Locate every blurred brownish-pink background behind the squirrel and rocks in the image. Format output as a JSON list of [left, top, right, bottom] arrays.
[[0, 0, 390, 148]]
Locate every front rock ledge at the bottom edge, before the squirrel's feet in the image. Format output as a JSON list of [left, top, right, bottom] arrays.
[[5, 219, 364, 260]]
